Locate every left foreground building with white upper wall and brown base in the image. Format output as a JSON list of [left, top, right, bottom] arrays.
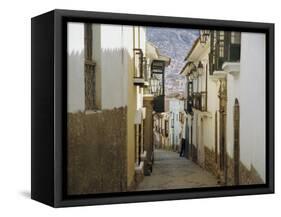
[[67, 23, 156, 194]]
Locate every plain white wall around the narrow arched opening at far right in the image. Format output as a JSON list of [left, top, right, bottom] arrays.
[[227, 33, 266, 180]]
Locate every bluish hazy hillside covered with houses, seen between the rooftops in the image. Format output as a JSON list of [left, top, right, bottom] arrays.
[[146, 27, 199, 95]]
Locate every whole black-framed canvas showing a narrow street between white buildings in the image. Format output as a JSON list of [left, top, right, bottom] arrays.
[[31, 10, 274, 207]]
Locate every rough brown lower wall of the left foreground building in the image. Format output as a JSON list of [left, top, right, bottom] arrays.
[[67, 108, 127, 195]]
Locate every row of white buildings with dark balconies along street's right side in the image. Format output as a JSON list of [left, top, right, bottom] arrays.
[[181, 31, 265, 185]]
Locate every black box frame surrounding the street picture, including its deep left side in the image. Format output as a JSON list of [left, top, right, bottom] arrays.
[[31, 10, 274, 207]]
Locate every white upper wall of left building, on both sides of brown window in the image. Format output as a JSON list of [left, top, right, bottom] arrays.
[[67, 23, 140, 112]]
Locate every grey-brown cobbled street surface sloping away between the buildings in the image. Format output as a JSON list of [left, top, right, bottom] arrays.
[[137, 149, 218, 191]]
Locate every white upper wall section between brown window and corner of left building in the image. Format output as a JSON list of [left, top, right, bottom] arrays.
[[101, 25, 130, 109]]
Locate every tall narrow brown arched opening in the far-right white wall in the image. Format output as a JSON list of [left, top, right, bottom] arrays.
[[233, 98, 240, 185]]
